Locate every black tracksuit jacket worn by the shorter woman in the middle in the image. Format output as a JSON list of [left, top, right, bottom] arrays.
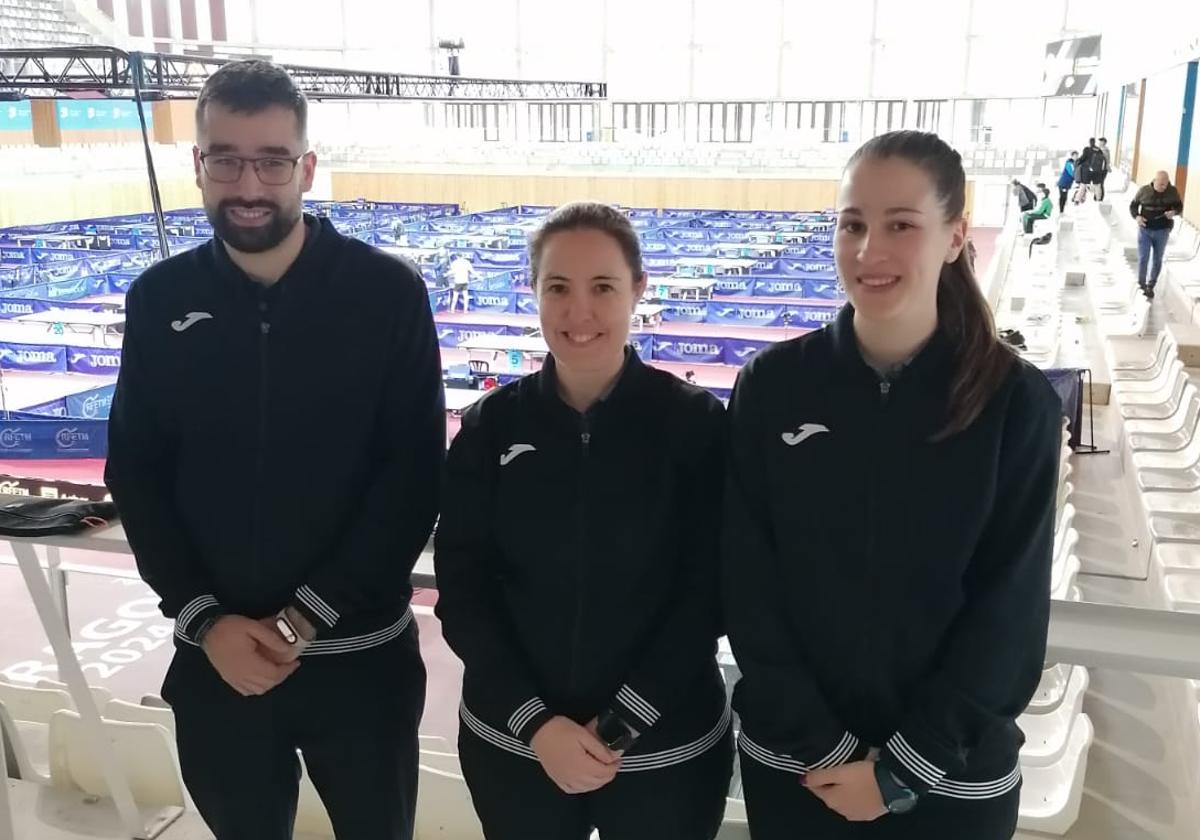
[[434, 353, 727, 770]]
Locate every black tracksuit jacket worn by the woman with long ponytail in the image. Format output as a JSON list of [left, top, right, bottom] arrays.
[[724, 306, 1062, 799]]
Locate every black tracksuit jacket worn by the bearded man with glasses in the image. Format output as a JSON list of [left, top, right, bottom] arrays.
[[104, 216, 445, 655]]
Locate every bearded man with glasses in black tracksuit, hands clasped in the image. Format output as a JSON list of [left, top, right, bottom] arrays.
[[106, 60, 445, 840]]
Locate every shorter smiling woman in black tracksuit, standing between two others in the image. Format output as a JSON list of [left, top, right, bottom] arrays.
[[434, 203, 733, 840]]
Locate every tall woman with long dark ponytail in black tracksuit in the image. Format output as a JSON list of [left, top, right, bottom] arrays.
[[722, 131, 1062, 840]]
